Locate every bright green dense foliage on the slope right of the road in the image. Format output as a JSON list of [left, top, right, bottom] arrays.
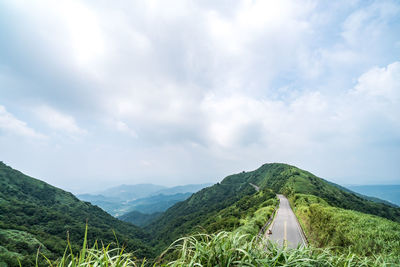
[[292, 194, 400, 262]]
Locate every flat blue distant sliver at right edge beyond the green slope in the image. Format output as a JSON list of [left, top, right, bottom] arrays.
[[346, 185, 400, 206]]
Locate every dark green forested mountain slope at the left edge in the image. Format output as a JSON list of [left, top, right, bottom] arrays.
[[0, 162, 153, 266]]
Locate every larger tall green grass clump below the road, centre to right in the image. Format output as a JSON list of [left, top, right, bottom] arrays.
[[161, 232, 396, 267]]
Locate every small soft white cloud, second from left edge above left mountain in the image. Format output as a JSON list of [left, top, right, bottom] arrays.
[[35, 106, 87, 135]]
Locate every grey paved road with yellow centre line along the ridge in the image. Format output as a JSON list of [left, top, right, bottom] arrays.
[[267, 195, 305, 248]]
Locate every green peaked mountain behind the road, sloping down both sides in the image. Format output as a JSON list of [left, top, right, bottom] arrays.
[[145, 163, 400, 253]]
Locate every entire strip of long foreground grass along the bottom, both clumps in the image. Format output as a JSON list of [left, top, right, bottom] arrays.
[[39, 231, 397, 267]]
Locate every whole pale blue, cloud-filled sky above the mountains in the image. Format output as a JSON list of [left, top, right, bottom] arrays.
[[0, 0, 400, 193]]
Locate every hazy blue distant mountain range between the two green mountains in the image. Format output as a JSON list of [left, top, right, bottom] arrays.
[[77, 184, 211, 216]]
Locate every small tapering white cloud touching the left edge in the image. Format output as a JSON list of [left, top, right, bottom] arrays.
[[0, 105, 46, 139]]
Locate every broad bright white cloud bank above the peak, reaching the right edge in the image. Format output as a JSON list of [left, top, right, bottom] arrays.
[[201, 62, 400, 159]]
